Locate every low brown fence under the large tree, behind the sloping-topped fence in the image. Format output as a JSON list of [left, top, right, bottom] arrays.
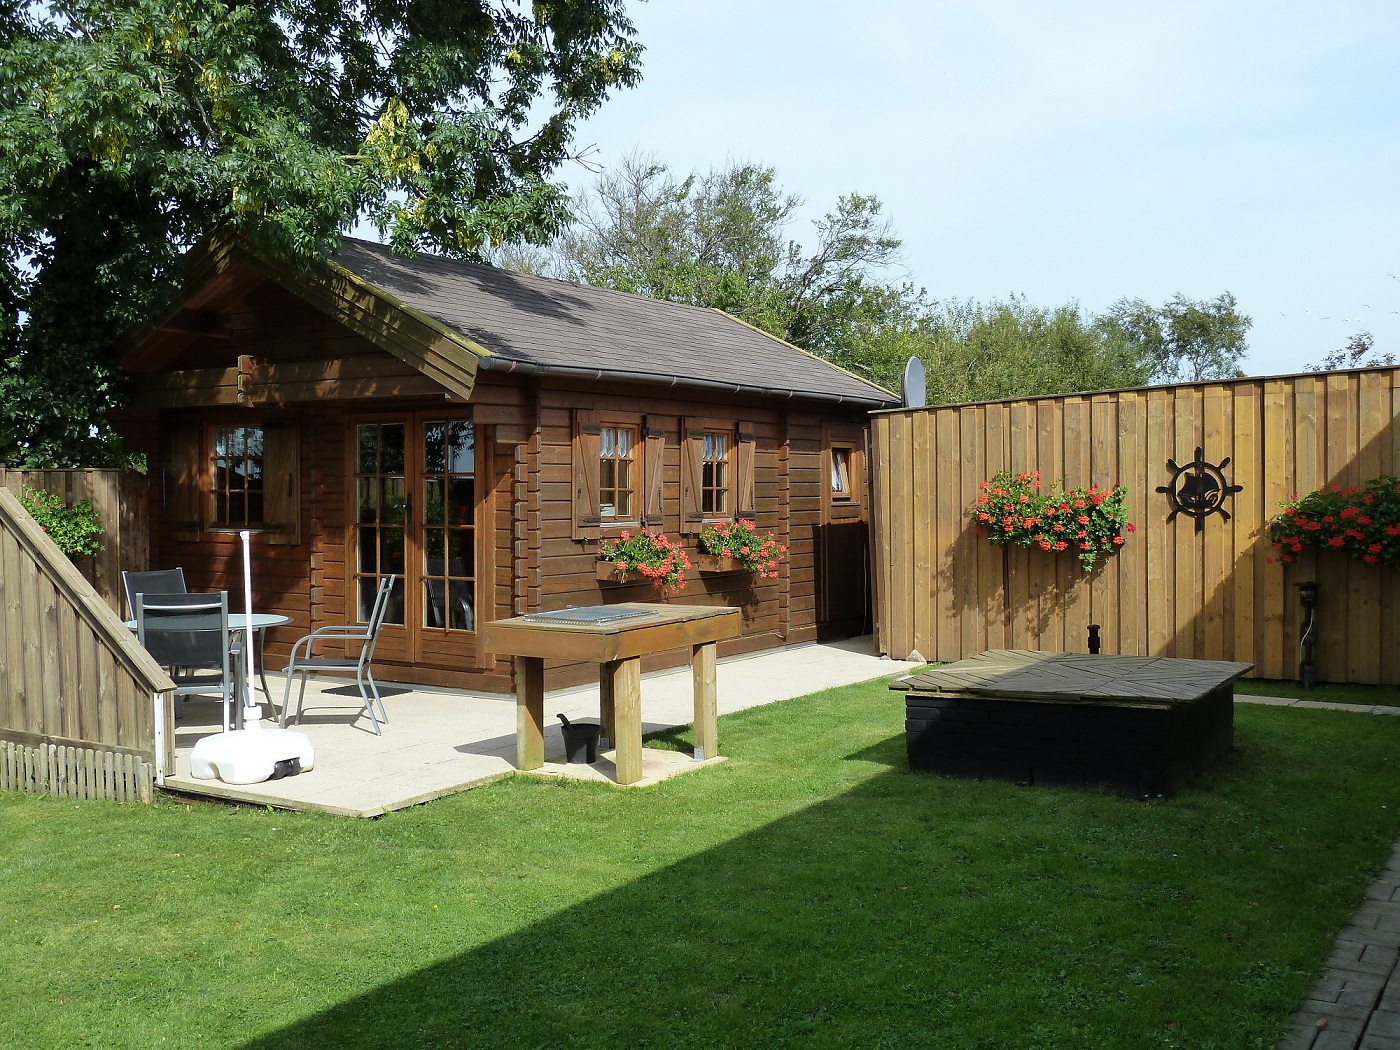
[[0, 468, 151, 612]]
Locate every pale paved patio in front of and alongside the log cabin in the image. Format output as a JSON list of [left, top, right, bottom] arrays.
[[165, 637, 917, 816]]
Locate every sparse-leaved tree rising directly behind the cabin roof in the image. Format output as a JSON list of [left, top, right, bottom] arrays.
[[552, 154, 917, 375]]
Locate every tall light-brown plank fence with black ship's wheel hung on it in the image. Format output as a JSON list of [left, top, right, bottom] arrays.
[[872, 368, 1400, 685]]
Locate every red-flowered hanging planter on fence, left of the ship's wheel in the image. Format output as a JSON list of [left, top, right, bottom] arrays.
[[973, 470, 1137, 571]]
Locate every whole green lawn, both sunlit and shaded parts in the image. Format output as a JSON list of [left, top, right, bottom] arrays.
[[0, 683, 1400, 1050]]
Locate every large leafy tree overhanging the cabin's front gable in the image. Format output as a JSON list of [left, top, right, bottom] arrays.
[[0, 0, 640, 463]]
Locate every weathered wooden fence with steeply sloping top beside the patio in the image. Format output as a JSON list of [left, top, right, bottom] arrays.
[[0, 489, 175, 801]]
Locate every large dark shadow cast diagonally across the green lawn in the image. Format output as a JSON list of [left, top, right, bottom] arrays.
[[232, 716, 1393, 1050]]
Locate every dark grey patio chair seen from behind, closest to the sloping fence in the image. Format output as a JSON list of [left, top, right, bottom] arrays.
[[132, 591, 239, 729]]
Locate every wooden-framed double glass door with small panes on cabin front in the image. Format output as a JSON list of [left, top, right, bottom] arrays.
[[353, 414, 477, 664]]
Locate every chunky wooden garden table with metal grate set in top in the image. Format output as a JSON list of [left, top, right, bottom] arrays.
[[482, 602, 739, 784]]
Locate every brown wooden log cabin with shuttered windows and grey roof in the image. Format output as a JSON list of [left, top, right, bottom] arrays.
[[113, 239, 896, 692]]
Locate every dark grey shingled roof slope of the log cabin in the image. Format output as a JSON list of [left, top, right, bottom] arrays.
[[333, 238, 897, 407]]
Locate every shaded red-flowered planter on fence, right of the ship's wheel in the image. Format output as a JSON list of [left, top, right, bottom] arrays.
[[1268, 475, 1400, 568]]
